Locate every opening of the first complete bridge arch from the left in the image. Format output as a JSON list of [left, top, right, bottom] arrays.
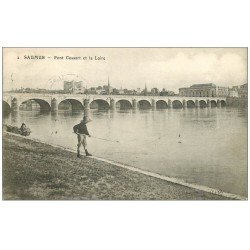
[[19, 98, 51, 111]]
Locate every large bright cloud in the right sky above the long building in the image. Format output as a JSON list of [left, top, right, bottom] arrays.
[[141, 53, 247, 90]]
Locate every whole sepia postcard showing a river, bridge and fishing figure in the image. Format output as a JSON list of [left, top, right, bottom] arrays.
[[2, 47, 248, 200]]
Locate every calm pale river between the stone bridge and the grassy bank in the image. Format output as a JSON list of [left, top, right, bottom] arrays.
[[3, 108, 247, 197]]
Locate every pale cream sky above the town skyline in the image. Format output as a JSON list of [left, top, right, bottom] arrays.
[[3, 48, 247, 93]]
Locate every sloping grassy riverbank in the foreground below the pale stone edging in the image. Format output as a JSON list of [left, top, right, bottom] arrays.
[[3, 133, 233, 200]]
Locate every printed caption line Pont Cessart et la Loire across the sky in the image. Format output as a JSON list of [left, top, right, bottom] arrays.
[[22, 55, 106, 61]]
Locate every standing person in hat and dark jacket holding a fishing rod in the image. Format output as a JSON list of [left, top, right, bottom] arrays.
[[73, 116, 92, 158]]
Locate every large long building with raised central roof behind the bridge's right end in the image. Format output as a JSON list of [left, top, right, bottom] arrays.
[[179, 83, 228, 97]]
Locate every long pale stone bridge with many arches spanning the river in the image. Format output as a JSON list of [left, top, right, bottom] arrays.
[[3, 93, 226, 111]]
